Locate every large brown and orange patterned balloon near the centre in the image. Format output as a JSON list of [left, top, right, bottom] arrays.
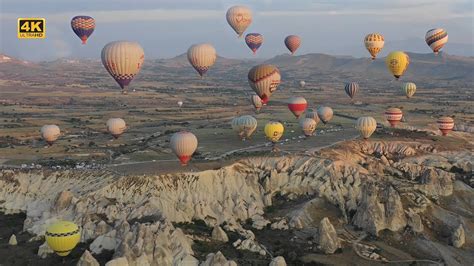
[[248, 64, 281, 104]]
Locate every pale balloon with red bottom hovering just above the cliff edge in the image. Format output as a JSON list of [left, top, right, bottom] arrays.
[[170, 131, 198, 166]]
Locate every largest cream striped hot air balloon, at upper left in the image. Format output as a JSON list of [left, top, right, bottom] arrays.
[[101, 41, 145, 94]]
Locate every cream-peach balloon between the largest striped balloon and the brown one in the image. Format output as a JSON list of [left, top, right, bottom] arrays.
[[188, 43, 217, 77]]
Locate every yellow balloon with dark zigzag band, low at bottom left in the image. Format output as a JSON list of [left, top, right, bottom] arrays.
[[45, 221, 81, 257]]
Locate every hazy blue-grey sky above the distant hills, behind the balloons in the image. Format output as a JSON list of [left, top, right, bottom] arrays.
[[0, 0, 474, 61]]
